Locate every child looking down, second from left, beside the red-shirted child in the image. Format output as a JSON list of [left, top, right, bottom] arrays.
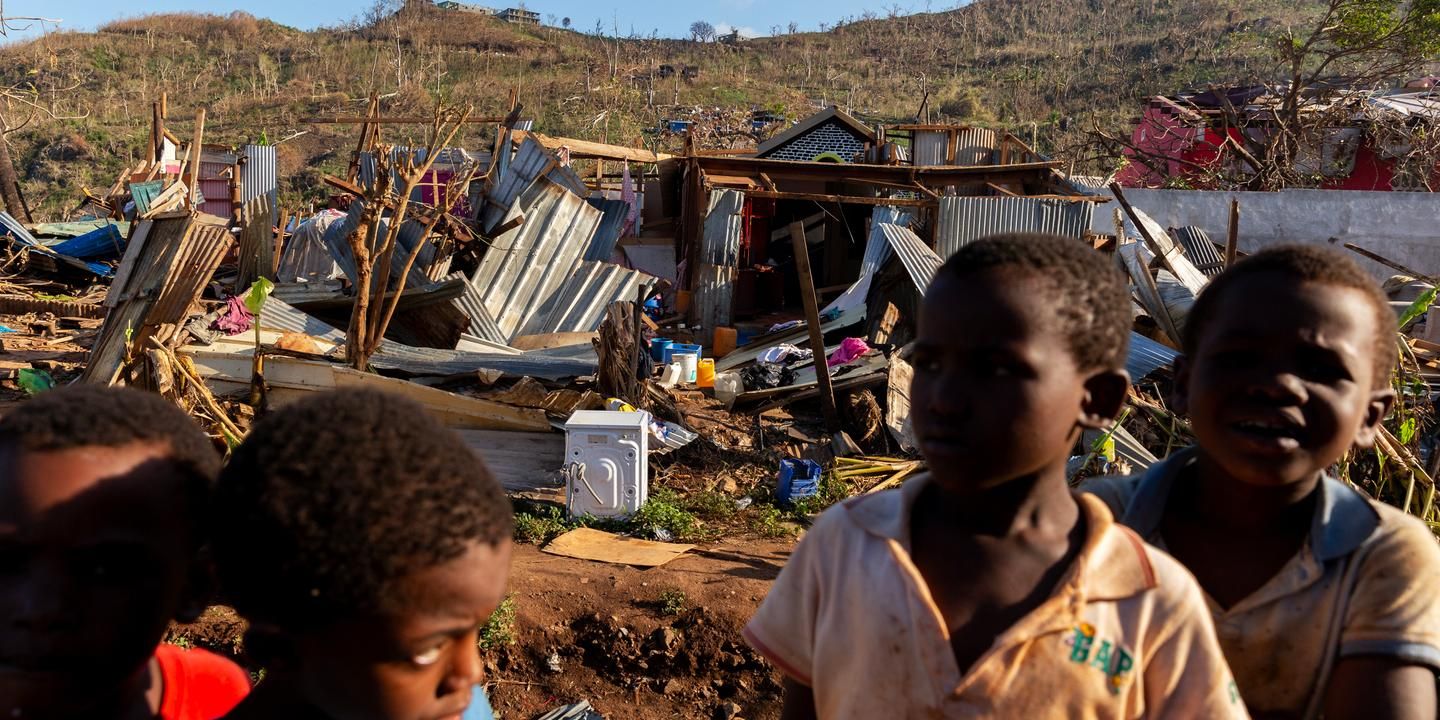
[[215, 390, 511, 720]]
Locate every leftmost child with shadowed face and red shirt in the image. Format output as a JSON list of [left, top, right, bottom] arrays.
[[0, 386, 249, 720]]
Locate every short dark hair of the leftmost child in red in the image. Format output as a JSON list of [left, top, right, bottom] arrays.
[[0, 384, 220, 515]]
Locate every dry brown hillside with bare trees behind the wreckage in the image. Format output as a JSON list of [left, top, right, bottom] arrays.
[[0, 0, 1308, 219]]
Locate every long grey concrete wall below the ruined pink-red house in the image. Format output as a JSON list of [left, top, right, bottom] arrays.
[[1092, 189, 1440, 279]]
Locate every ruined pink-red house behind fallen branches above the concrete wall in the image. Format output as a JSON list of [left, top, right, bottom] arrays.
[[1116, 86, 1440, 190]]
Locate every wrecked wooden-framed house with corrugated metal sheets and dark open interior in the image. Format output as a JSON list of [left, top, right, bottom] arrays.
[[668, 108, 1103, 347]]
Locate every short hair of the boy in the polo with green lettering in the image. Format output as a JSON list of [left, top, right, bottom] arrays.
[[936, 233, 1133, 372]]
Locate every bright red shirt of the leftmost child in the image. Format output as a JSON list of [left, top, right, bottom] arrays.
[[156, 642, 251, 720]]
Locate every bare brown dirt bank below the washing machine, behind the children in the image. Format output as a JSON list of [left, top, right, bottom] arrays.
[[175, 537, 795, 720]]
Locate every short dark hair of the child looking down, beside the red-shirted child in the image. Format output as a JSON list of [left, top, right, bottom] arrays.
[[215, 390, 513, 629]]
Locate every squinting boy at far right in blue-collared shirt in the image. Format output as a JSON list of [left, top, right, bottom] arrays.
[[1084, 246, 1440, 720]]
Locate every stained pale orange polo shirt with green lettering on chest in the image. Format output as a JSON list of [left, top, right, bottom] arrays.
[[744, 474, 1247, 720]]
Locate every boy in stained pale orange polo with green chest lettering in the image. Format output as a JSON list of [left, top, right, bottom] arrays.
[[744, 235, 1246, 719]]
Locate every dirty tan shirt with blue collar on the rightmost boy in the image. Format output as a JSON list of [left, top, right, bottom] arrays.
[[1080, 448, 1440, 717]]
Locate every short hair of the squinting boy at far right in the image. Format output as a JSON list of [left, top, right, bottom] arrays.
[[1181, 245, 1400, 389]]
